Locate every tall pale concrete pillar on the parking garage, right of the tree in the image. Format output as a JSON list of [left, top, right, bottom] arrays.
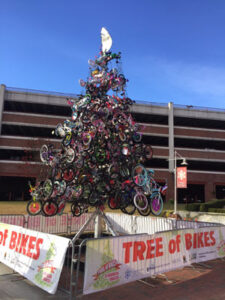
[[168, 102, 174, 173]]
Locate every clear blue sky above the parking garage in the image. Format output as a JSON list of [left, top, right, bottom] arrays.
[[0, 0, 225, 109]]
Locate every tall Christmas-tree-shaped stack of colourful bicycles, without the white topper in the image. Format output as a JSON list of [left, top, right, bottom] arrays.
[[27, 29, 167, 217]]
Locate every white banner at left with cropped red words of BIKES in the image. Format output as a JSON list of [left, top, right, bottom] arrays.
[[0, 223, 70, 294]]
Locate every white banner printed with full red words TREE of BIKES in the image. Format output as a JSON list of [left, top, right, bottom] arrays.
[[83, 227, 225, 294]]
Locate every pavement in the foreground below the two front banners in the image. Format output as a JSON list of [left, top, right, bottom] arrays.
[[0, 259, 225, 300]]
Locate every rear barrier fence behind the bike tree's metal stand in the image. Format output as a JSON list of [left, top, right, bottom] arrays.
[[0, 213, 224, 234]]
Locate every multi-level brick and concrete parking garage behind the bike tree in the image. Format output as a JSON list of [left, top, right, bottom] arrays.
[[0, 84, 225, 203]]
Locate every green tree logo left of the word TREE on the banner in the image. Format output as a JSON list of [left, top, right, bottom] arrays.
[[93, 240, 121, 289]]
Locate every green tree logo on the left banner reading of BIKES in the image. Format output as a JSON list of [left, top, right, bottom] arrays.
[[35, 243, 56, 287]]
